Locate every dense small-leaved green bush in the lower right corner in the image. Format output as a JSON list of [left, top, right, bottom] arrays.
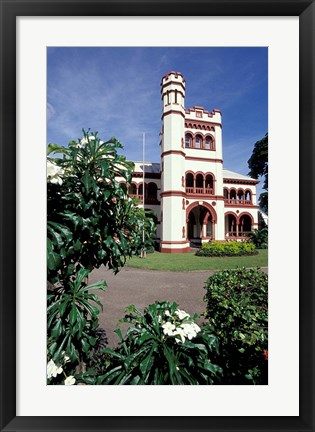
[[204, 268, 268, 384]]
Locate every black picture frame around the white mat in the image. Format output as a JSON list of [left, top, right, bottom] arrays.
[[0, 0, 315, 432]]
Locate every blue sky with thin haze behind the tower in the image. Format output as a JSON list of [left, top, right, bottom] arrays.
[[47, 47, 268, 191]]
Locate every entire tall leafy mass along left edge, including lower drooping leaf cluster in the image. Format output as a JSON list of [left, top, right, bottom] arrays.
[[47, 131, 155, 372]]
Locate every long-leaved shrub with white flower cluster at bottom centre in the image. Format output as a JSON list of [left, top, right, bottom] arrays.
[[78, 302, 222, 385]]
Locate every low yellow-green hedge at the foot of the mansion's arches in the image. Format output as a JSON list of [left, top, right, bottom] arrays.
[[196, 241, 257, 257]]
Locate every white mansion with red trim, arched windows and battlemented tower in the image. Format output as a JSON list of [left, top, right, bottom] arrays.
[[118, 71, 258, 253]]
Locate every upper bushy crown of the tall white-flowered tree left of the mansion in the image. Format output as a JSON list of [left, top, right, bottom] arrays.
[[47, 129, 155, 283]]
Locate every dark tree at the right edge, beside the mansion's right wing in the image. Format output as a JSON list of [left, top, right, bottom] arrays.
[[247, 133, 268, 213]]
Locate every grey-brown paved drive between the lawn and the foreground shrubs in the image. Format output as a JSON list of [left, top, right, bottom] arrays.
[[89, 267, 270, 346]]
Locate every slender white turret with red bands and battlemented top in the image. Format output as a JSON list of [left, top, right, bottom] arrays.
[[160, 71, 189, 253]]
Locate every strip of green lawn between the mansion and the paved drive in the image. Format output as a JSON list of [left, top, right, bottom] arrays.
[[126, 249, 268, 271]]
